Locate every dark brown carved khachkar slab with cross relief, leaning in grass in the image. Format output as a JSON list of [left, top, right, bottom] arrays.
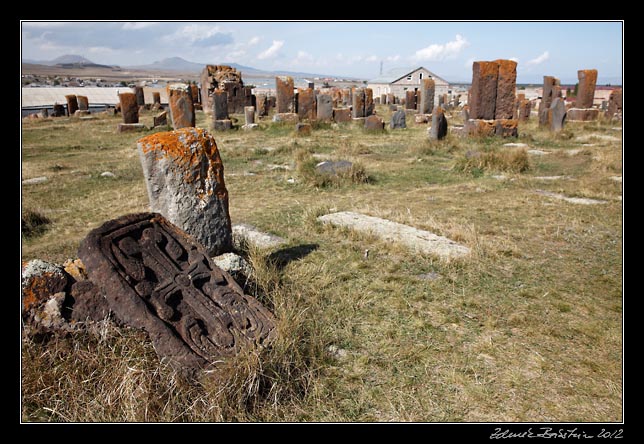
[[78, 213, 275, 375]]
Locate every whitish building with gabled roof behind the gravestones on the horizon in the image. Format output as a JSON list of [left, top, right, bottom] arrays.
[[367, 66, 450, 98]]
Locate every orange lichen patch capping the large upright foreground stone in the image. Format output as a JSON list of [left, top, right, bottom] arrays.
[[139, 127, 228, 198]]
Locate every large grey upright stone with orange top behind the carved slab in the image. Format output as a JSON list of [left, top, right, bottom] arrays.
[[137, 127, 232, 256]]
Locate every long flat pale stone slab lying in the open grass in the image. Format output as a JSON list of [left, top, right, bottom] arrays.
[[318, 211, 470, 259]]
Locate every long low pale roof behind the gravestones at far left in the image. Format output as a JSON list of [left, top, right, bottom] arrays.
[[22, 87, 168, 108]]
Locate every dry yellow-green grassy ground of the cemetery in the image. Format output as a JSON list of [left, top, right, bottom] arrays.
[[22, 105, 623, 422]]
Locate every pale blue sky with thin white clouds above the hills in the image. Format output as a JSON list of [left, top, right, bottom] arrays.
[[21, 21, 623, 84]]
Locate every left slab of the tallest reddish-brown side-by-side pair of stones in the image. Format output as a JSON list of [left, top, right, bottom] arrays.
[[469, 62, 499, 120]]
